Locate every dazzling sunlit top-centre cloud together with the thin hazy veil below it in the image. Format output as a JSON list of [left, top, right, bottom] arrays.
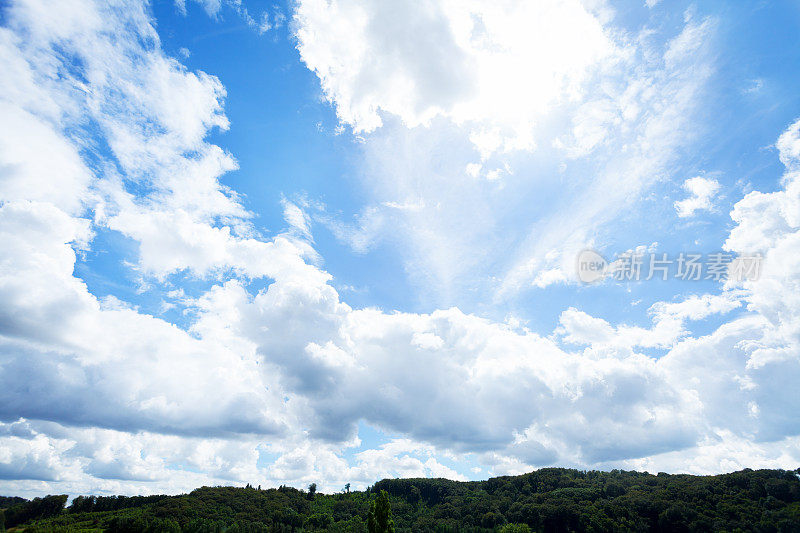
[[295, 6, 715, 300]]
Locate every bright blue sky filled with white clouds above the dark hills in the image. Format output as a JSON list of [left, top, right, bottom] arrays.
[[0, 0, 800, 497]]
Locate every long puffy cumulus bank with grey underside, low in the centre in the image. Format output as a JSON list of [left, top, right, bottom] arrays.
[[189, 274, 708, 461]]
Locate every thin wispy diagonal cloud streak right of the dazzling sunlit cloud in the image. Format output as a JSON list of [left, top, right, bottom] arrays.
[[498, 17, 716, 290]]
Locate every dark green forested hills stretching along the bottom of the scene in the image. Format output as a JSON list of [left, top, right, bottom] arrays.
[[6, 468, 800, 533]]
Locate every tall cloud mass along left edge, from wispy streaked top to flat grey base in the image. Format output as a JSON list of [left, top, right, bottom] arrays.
[[0, 2, 296, 471]]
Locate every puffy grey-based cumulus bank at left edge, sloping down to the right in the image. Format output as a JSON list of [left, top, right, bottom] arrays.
[[0, 202, 288, 433]]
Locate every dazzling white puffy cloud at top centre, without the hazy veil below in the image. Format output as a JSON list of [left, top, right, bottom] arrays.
[[295, 0, 620, 157]]
